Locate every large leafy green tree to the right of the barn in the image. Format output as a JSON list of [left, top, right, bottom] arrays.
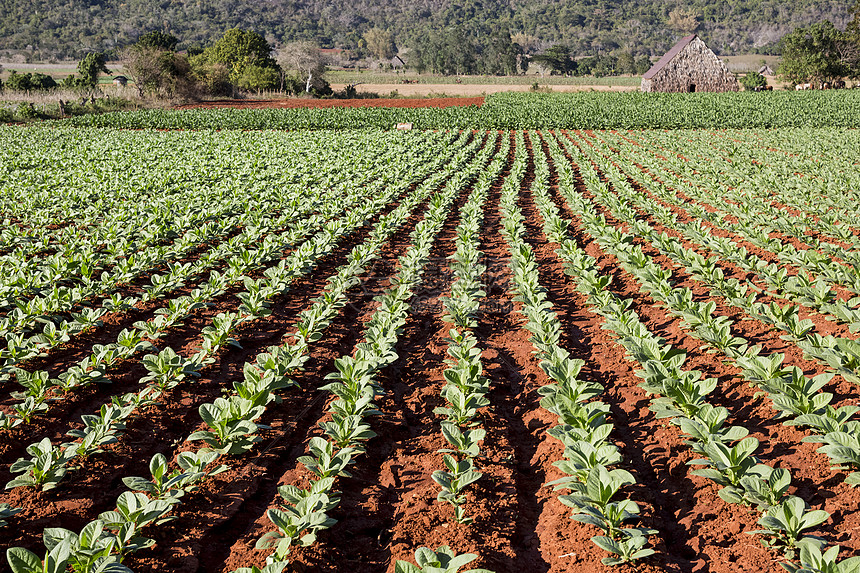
[[779, 20, 850, 84]]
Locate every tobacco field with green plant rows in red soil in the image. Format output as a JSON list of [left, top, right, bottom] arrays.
[[0, 124, 860, 573]]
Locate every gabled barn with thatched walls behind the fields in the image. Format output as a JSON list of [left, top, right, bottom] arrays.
[[642, 34, 738, 92]]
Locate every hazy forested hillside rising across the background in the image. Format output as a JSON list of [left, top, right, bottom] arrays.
[[0, 0, 852, 60]]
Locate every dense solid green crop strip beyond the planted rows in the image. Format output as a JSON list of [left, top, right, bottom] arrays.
[[62, 90, 860, 129]]
